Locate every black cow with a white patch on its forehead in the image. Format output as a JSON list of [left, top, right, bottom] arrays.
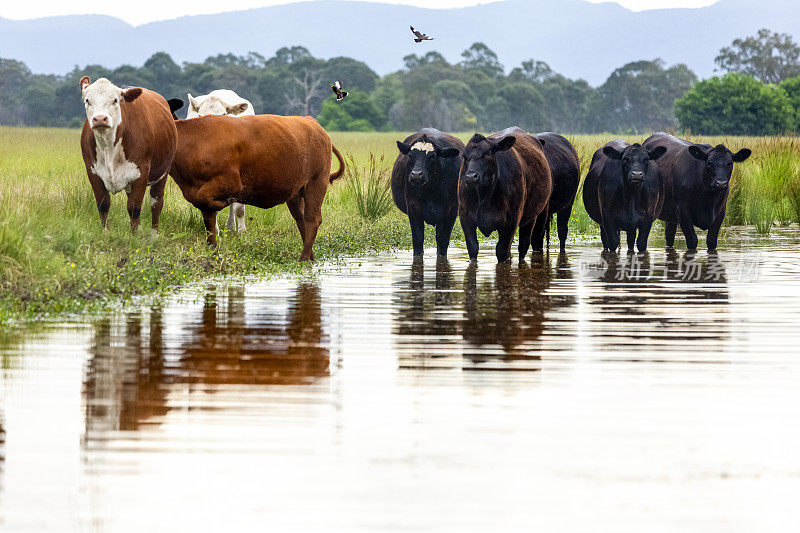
[[392, 128, 464, 256]]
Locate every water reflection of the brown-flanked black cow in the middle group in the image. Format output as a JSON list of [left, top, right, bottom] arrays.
[[462, 262, 552, 369]]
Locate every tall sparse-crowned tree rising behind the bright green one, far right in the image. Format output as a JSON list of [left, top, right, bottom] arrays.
[[714, 28, 800, 83]]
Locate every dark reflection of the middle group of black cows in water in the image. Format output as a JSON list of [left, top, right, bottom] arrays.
[[394, 254, 574, 370]]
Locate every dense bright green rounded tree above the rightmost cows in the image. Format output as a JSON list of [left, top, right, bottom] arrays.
[[675, 72, 796, 135]]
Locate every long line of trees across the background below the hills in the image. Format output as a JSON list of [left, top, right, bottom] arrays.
[[0, 30, 800, 135]]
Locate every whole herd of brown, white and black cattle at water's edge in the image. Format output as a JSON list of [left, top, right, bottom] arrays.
[[80, 76, 750, 261]]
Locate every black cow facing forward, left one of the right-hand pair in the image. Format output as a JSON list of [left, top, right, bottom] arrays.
[[583, 141, 667, 252]]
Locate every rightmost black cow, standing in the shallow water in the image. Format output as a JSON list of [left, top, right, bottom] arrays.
[[644, 133, 751, 250]]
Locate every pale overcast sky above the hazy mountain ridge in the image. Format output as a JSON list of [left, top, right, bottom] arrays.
[[0, 0, 716, 24]]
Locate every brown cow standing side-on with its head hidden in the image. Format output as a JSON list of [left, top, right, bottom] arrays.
[[170, 115, 344, 261]]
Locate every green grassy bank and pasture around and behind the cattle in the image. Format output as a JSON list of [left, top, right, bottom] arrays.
[[0, 128, 800, 324]]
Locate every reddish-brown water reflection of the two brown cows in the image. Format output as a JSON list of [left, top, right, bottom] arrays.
[[85, 282, 329, 430]]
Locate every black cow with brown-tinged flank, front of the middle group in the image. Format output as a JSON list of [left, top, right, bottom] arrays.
[[458, 127, 553, 261]]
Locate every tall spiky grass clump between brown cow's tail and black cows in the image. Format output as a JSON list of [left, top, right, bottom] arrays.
[[345, 152, 394, 220]]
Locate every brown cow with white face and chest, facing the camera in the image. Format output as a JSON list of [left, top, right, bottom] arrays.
[[81, 76, 176, 232]]
